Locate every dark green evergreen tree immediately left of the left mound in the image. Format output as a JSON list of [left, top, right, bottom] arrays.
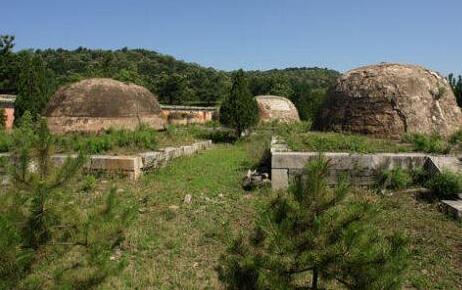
[[15, 53, 55, 120]]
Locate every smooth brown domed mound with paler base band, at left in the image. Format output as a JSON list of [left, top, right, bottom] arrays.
[[45, 78, 164, 133]]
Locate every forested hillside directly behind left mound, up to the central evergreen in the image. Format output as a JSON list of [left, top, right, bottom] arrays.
[[35, 48, 229, 104]]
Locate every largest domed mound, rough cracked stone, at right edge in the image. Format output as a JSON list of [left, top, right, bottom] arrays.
[[314, 64, 462, 138]]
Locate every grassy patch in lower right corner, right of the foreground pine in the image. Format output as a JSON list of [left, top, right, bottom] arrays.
[[355, 189, 462, 289]]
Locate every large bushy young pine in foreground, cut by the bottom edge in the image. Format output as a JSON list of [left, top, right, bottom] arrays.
[[218, 157, 407, 289]]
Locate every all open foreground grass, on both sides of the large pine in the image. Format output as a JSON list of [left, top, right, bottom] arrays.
[[0, 137, 462, 289]]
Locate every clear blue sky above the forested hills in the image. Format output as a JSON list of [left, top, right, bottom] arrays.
[[0, 0, 462, 74]]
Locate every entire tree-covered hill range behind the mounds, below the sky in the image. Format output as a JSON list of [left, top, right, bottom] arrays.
[[0, 44, 339, 119]]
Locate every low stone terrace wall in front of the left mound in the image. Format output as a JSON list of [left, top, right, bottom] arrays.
[[0, 140, 212, 180]]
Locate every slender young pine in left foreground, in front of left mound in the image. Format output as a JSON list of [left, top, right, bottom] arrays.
[[10, 112, 85, 250]]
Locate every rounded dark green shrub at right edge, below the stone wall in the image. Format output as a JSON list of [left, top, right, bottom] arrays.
[[425, 171, 462, 199]]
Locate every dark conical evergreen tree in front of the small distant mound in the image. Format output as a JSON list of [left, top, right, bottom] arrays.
[[220, 70, 259, 137]]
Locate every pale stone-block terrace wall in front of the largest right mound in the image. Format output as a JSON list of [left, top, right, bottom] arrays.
[[271, 138, 462, 190]]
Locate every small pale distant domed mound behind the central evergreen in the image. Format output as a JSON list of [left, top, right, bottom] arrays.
[[256, 96, 300, 123]]
